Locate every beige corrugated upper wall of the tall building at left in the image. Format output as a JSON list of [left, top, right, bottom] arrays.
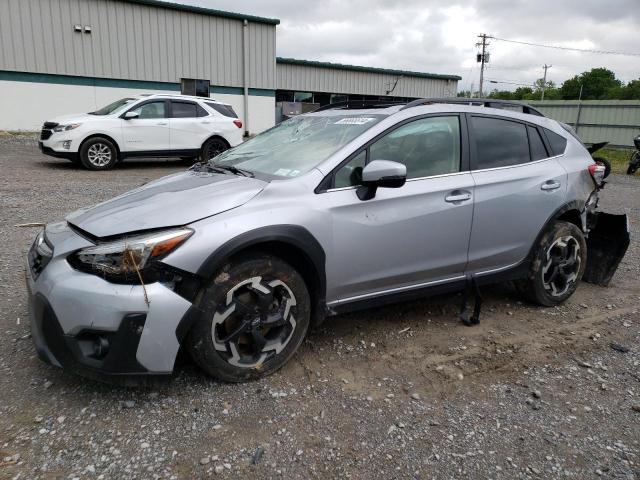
[[0, 0, 276, 89]]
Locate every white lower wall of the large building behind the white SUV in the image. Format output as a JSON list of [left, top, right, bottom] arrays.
[[0, 80, 275, 134]]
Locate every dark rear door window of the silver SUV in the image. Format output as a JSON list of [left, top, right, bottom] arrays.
[[471, 117, 531, 170]]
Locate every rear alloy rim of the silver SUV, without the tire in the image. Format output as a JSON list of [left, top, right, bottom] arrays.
[[542, 236, 582, 297]]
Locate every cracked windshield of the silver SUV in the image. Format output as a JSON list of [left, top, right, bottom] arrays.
[[209, 114, 385, 178]]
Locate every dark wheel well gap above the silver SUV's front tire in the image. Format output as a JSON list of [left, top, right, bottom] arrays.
[[226, 241, 325, 325]]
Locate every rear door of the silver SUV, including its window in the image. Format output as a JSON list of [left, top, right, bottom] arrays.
[[467, 115, 567, 273]]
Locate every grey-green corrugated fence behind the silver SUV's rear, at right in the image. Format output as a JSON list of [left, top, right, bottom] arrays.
[[529, 100, 640, 147]]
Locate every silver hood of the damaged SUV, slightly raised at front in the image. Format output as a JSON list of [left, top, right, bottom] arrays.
[[66, 170, 267, 237]]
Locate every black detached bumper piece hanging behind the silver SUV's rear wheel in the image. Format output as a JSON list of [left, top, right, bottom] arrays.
[[582, 212, 630, 287]]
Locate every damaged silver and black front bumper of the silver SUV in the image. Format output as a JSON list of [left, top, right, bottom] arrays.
[[26, 227, 192, 378]]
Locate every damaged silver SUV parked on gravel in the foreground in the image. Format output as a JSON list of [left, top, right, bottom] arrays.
[[27, 100, 620, 382]]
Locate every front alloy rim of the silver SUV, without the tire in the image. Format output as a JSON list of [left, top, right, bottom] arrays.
[[211, 276, 296, 368]]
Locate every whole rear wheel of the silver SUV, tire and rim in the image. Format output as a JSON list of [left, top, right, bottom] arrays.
[[517, 221, 587, 307]]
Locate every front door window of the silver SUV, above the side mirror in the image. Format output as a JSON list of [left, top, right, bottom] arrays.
[[369, 116, 462, 178]]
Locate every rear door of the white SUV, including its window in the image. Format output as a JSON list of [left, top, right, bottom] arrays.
[[170, 100, 212, 151]]
